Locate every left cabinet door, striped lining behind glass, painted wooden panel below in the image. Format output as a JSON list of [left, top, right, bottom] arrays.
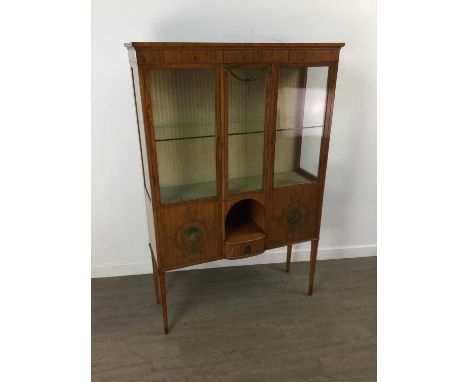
[[146, 67, 222, 270]]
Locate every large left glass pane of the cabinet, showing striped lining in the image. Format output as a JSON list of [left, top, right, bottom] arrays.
[[149, 69, 216, 204]]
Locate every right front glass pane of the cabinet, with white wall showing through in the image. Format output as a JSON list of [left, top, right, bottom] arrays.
[[274, 67, 328, 187]]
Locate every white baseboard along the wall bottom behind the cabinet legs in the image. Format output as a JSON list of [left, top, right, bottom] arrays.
[[91, 244, 377, 278]]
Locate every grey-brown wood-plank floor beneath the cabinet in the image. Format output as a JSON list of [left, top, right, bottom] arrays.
[[92, 257, 377, 382]]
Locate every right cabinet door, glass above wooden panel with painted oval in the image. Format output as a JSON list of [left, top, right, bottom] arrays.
[[268, 66, 329, 247]]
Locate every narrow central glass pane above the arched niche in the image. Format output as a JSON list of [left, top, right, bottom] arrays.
[[227, 68, 266, 194]]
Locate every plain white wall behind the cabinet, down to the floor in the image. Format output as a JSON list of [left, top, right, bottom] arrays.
[[92, 0, 376, 277]]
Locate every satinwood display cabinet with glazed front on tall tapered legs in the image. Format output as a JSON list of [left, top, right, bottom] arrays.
[[125, 42, 344, 333]]
